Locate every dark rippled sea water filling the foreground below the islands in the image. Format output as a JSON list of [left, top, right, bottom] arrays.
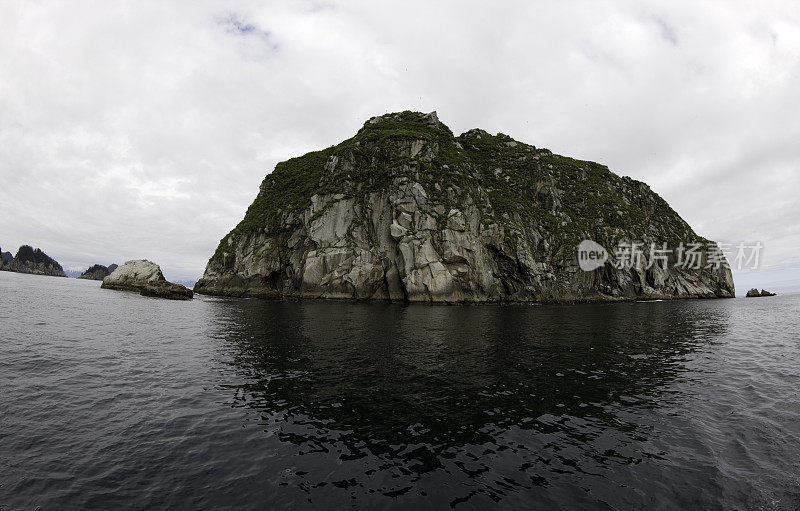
[[0, 272, 800, 510]]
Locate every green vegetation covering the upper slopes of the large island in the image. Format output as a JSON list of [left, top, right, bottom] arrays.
[[215, 111, 702, 257]]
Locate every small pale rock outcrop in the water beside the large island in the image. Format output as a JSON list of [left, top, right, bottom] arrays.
[[100, 259, 193, 300]]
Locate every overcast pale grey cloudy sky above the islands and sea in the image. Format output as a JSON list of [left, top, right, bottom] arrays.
[[0, 0, 800, 292]]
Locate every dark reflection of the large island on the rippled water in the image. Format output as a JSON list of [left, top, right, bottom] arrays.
[[206, 301, 727, 506]]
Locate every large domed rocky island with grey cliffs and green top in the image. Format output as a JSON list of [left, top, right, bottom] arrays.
[[194, 112, 734, 302]]
